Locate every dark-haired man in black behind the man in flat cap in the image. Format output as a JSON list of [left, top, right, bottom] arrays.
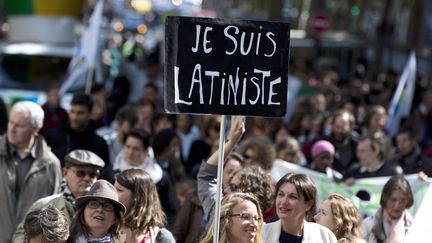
[[44, 94, 110, 166]]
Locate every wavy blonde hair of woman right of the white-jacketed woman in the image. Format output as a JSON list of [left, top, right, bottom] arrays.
[[327, 194, 362, 239]]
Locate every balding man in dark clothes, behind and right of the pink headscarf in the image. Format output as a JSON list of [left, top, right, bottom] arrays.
[[323, 110, 358, 175]]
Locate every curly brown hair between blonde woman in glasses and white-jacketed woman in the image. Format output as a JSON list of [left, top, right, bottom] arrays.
[[229, 165, 274, 212]]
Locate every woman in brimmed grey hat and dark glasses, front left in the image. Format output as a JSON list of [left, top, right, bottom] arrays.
[[67, 180, 126, 243]]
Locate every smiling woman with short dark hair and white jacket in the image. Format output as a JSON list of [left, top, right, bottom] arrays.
[[263, 173, 337, 243]]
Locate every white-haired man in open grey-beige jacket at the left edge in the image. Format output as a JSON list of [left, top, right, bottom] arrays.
[[0, 101, 61, 243]]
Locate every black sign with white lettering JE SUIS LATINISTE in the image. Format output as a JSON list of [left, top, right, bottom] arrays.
[[165, 16, 290, 117]]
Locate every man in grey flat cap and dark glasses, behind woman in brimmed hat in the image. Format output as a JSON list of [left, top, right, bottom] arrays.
[[13, 149, 105, 243]]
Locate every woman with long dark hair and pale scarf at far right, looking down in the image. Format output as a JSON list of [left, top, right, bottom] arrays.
[[362, 175, 414, 243]]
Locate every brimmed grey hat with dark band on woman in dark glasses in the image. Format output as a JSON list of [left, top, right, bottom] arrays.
[[75, 180, 126, 214]]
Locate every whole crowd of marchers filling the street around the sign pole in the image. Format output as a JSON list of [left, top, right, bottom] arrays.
[[0, 52, 432, 243]]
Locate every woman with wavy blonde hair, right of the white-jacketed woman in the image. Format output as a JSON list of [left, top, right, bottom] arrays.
[[314, 194, 365, 243]]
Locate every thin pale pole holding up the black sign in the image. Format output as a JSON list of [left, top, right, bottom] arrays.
[[213, 115, 226, 243]]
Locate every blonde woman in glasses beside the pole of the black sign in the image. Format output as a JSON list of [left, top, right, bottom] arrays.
[[200, 192, 263, 243]]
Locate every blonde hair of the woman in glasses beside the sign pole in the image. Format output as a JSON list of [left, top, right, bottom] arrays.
[[200, 192, 263, 243]]
